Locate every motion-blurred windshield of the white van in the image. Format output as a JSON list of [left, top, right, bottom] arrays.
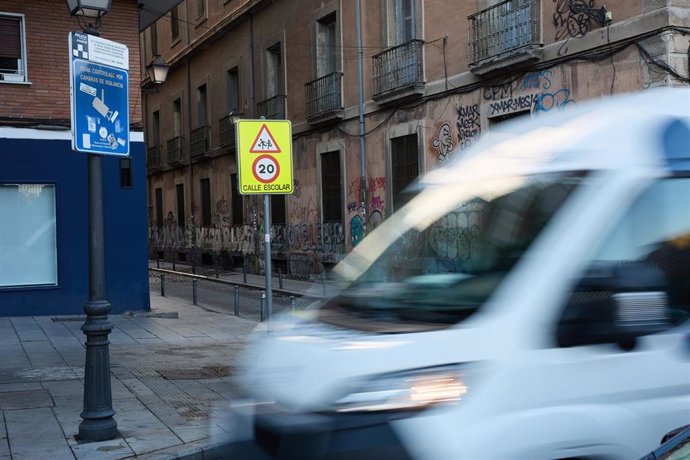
[[319, 173, 584, 333]]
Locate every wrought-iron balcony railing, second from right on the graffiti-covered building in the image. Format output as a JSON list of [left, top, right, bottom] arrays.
[[372, 39, 424, 97]]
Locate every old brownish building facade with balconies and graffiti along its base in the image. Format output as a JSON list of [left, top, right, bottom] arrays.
[[141, 0, 690, 278]]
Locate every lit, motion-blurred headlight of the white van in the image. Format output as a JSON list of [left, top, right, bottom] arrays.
[[334, 366, 468, 412]]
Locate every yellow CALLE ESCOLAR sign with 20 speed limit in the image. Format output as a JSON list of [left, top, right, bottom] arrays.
[[236, 120, 293, 195]]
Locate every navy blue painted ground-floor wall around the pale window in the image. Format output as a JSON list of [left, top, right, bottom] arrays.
[[0, 138, 150, 316]]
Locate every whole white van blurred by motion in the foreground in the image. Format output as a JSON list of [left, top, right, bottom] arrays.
[[227, 89, 690, 460]]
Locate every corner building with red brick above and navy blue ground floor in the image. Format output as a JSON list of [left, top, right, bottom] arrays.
[[0, 0, 164, 316]]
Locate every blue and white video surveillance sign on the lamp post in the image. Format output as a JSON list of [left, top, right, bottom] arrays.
[[69, 32, 129, 156]]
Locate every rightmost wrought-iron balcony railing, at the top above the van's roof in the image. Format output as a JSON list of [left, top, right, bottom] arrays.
[[467, 0, 541, 64]]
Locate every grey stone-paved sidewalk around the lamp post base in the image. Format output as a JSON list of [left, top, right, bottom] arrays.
[[0, 272, 321, 460]]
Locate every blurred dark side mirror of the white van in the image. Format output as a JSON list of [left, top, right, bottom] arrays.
[[556, 261, 671, 349]]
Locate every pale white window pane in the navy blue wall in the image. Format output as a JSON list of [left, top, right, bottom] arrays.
[[0, 184, 57, 286]]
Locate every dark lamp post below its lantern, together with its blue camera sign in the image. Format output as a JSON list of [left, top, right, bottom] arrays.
[[68, 32, 130, 441]]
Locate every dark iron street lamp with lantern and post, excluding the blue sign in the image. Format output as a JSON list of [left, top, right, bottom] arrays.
[[66, 0, 117, 441]]
